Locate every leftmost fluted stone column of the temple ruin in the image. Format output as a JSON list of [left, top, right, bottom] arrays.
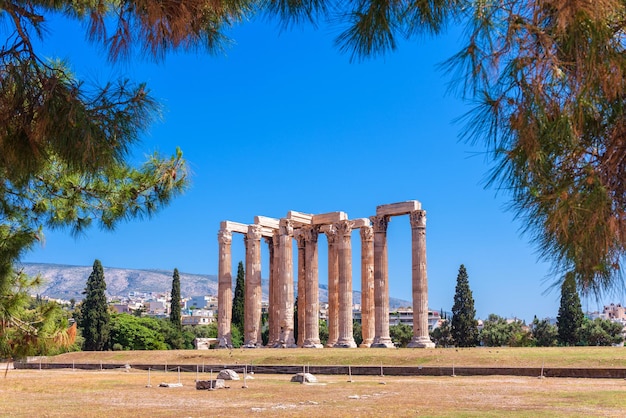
[[217, 229, 233, 348]]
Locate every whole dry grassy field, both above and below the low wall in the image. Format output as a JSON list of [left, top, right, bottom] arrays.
[[0, 347, 626, 418]]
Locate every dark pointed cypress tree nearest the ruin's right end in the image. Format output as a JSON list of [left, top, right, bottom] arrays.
[[450, 264, 478, 347]]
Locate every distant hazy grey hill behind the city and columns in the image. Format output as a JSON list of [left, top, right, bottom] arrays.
[[22, 263, 411, 309]]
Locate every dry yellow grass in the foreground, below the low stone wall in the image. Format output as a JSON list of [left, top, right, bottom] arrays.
[[0, 369, 626, 418]]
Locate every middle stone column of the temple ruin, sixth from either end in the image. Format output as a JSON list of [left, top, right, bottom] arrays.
[[303, 226, 322, 348]]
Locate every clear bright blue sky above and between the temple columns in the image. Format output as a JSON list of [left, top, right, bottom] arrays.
[[24, 13, 623, 321]]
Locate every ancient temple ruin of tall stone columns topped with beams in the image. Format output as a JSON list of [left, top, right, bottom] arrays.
[[218, 200, 434, 348]]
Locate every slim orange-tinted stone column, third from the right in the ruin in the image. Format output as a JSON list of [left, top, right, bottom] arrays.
[[361, 226, 374, 347]]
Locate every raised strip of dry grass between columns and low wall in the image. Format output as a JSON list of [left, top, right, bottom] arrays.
[[46, 347, 626, 368]]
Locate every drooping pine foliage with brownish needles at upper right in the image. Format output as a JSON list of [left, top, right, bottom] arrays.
[[449, 0, 626, 294]]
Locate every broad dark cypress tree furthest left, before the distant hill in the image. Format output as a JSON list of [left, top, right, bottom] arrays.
[[79, 260, 110, 351]]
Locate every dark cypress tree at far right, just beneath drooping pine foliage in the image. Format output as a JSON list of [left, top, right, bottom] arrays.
[[556, 273, 584, 345]]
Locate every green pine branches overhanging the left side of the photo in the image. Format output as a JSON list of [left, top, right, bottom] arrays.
[[0, 0, 190, 358]]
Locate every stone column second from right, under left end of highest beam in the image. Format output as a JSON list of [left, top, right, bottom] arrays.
[[370, 215, 394, 348]]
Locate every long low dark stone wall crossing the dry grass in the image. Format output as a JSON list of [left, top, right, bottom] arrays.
[[14, 362, 626, 379]]
